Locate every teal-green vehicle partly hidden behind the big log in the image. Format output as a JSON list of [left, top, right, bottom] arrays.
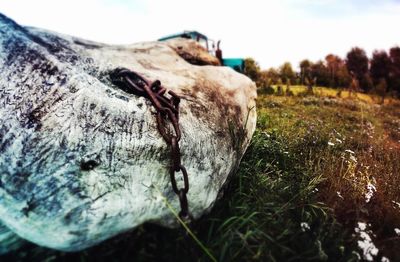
[[158, 31, 244, 73]]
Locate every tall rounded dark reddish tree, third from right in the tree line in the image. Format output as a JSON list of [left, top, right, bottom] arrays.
[[346, 47, 371, 91]]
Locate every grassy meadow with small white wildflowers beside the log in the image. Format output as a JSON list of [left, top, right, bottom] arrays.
[[3, 86, 400, 261]]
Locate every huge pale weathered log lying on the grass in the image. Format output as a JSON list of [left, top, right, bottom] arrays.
[[0, 14, 256, 251]]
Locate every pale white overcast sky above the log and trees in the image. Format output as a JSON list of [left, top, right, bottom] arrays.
[[0, 0, 400, 69]]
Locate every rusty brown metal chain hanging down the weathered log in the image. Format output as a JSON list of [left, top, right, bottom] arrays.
[[111, 68, 192, 222]]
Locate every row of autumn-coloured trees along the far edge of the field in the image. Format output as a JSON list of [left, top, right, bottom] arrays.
[[245, 46, 400, 96]]
